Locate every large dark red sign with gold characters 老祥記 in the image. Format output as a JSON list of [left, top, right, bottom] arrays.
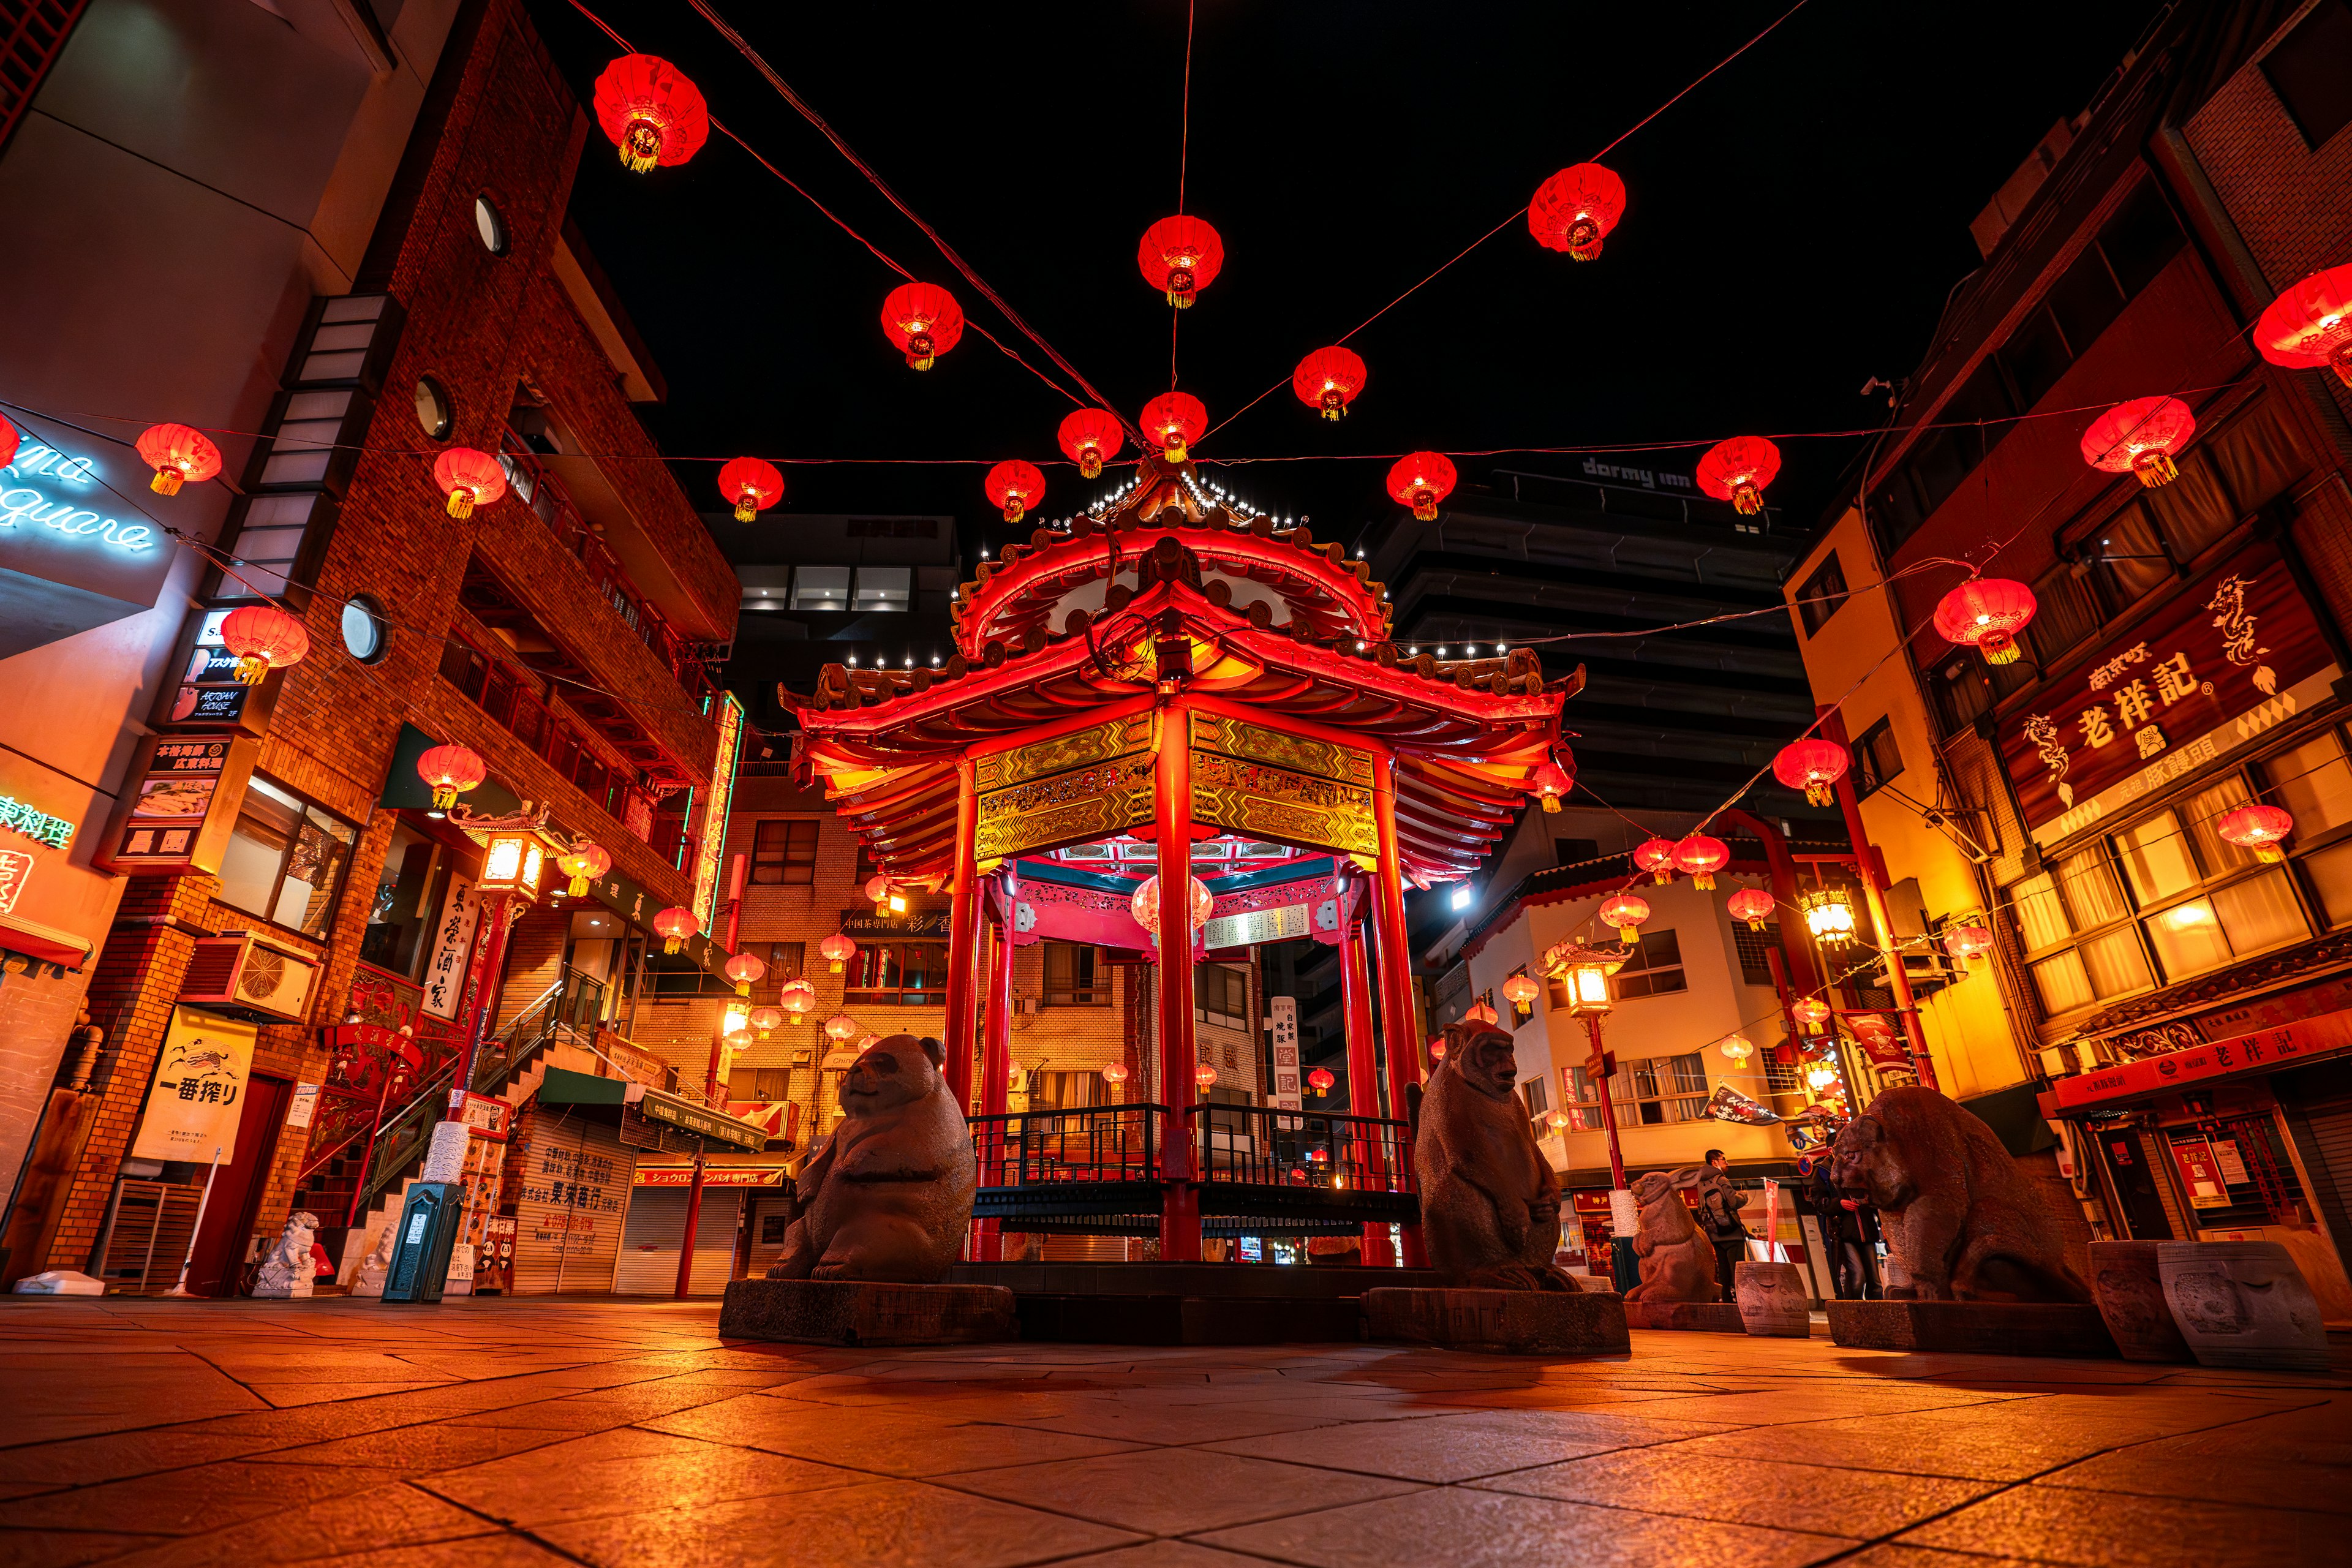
[[1999, 543, 2338, 844]]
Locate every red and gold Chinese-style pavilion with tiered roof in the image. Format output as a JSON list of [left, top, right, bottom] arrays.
[[783, 454, 1583, 1260]]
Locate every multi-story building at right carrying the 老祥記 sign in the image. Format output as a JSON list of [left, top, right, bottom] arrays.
[[1787, 0, 2352, 1319]]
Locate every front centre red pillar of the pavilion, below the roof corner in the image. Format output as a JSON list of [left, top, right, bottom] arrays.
[[1153, 703, 1199, 1262]]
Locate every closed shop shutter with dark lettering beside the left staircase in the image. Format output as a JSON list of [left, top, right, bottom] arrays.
[[508, 1107, 630, 1295]]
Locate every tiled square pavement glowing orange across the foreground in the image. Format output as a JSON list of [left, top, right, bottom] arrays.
[[0, 1298, 2352, 1568]]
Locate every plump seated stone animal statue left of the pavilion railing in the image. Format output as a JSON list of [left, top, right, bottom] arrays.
[[767, 1035, 978, 1284]]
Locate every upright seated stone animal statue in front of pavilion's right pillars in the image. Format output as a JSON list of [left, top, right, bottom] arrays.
[[1411, 1025, 1574, 1291]]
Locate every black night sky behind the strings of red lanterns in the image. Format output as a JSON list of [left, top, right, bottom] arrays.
[[534, 0, 2154, 550]]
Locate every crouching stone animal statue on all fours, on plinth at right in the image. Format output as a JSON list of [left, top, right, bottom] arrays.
[[1830, 1084, 2091, 1302]]
